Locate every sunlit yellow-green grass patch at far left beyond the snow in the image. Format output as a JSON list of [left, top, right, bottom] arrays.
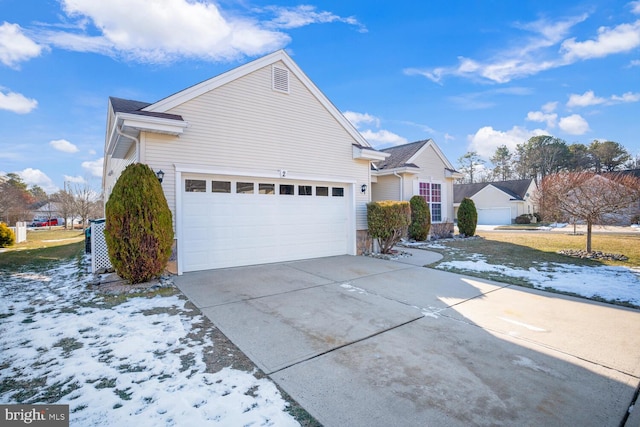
[[0, 230, 84, 272]]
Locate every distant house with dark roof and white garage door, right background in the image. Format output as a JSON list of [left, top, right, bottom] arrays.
[[453, 179, 538, 225]]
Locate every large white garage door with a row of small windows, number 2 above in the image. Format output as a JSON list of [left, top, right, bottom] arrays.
[[179, 176, 350, 271]]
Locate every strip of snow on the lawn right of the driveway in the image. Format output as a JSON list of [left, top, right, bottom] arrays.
[[437, 254, 640, 306]]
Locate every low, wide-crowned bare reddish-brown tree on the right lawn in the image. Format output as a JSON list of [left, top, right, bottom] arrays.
[[538, 172, 640, 252]]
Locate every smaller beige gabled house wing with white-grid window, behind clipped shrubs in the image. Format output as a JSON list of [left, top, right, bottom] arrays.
[[371, 139, 463, 223]]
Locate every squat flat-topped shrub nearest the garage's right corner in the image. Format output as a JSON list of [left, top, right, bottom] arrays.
[[367, 200, 411, 254]]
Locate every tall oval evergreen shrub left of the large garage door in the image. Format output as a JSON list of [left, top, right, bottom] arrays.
[[104, 163, 173, 284]]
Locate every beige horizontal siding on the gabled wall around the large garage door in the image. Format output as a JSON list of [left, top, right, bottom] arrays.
[[144, 62, 369, 229]]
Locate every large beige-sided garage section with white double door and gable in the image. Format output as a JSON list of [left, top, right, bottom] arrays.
[[103, 50, 387, 274]]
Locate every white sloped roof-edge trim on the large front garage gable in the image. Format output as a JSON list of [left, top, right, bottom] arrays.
[[140, 50, 371, 148]]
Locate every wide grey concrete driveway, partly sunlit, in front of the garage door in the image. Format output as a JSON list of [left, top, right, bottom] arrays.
[[176, 253, 640, 426]]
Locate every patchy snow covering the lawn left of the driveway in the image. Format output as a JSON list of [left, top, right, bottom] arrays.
[[0, 262, 298, 427]]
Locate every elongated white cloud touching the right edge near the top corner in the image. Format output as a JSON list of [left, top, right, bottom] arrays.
[[562, 20, 640, 62]]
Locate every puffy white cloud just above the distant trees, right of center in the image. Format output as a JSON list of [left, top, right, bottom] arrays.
[[467, 126, 547, 159]]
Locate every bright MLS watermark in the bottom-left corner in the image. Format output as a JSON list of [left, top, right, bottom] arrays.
[[0, 405, 69, 427]]
